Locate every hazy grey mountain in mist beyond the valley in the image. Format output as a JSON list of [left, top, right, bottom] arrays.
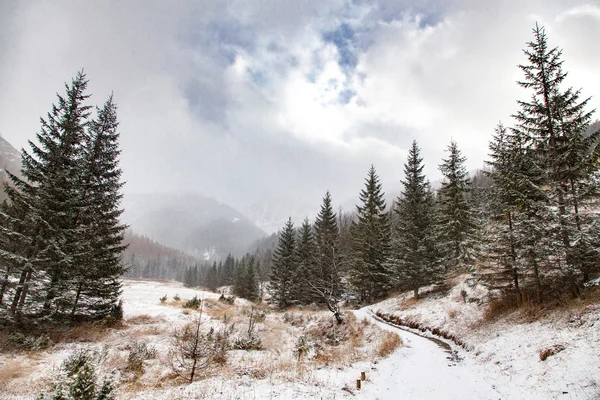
[[123, 194, 266, 260]]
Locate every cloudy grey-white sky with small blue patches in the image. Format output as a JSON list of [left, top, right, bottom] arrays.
[[0, 0, 600, 230]]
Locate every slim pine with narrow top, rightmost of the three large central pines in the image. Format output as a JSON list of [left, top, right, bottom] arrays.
[[437, 141, 477, 271]]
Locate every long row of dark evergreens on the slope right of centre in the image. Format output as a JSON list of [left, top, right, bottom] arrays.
[[269, 25, 600, 308]]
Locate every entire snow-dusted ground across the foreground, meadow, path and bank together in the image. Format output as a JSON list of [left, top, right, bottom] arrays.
[[0, 279, 600, 400]]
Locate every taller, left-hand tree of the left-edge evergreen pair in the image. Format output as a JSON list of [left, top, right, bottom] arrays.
[[2, 72, 90, 316]]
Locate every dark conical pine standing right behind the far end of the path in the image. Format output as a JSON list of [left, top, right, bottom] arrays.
[[350, 166, 391, 303]]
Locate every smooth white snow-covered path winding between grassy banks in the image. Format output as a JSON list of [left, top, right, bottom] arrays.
[[355, 308, 502, 400]]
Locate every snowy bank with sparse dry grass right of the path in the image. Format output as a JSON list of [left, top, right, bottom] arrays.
[[371, 277, 600, 399]]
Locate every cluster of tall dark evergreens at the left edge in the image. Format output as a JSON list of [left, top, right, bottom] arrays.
[[0, 72, 126, 323]]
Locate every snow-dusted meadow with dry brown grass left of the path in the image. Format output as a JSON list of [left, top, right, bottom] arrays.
[[0, 280, 399, 400]]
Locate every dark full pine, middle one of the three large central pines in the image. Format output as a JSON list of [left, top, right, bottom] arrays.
[[392, 141, 441, 298]]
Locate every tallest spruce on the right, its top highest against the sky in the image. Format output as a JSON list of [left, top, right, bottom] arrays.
[[513, 24, 600, 295]]
